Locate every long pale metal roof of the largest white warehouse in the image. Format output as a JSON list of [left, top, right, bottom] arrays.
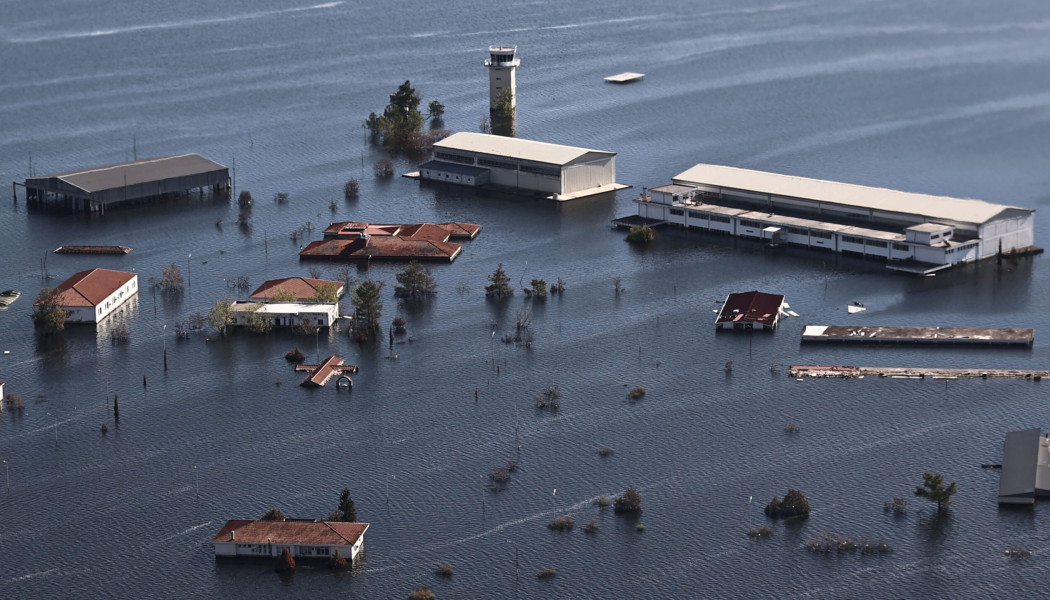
[[674, 164, 1034, 224]]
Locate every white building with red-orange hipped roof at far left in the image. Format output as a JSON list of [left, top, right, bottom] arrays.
[[34, 269, 139, 323]]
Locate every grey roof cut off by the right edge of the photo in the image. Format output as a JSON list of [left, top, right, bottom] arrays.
[[999, 429, 1050, 504]]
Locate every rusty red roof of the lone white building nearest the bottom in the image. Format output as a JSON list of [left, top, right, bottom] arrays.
[[212, 519, 369, 545]]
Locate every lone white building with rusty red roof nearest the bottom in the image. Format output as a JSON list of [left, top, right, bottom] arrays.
[[211, 519, 369, 562]]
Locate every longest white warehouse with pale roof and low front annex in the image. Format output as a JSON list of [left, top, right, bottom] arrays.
[[635, 164, 1038, 273]]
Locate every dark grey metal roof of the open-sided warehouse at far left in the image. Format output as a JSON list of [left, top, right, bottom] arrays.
[[25, 154, 227, 193]]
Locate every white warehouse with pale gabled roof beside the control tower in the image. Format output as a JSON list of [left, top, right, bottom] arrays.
[[410, 132, 630, 201]]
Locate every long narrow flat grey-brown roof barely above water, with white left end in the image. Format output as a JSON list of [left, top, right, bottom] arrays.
[[802, 325, 1035, 346]]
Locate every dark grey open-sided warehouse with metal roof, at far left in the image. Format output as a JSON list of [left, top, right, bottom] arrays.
[[23, 154, 230, 212]]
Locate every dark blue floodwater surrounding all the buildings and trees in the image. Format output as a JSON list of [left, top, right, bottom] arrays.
[[0, 0, 1050, 598]]
